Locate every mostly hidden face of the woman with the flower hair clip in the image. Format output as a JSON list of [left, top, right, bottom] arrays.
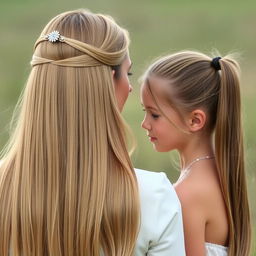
[[113, 55, 132, 111]]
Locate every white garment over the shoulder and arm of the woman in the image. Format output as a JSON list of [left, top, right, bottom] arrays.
[[134, 169, 186, 256]]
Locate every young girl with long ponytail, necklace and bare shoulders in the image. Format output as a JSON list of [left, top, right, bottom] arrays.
[[141, 51, 251, 256]]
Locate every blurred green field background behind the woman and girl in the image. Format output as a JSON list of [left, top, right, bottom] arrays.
[[0, 0, 256, 255]]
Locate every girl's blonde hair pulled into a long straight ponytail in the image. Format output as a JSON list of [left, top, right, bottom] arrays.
[[144, 51, 251, 256]]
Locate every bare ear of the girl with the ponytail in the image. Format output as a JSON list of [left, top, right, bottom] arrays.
[[188, 109, 206, 132]]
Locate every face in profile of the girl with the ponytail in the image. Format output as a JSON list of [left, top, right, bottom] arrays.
[[141, 78, 187, 152]]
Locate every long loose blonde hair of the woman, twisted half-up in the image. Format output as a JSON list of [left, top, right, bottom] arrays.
[[0, 10, 139, 256]]
